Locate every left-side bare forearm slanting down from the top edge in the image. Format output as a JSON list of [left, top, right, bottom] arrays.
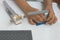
[[15, 0, 31, 14]]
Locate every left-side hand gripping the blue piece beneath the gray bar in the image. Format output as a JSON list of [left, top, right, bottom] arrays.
[[27, 8, 46, 25]]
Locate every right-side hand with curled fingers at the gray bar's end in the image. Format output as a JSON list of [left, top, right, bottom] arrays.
[[46, 6, 57, 25]]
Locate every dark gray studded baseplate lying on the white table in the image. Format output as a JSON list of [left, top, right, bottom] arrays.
[[0, 31, 32, 40]]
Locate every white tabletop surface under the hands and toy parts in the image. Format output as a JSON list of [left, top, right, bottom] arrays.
[[0, 0, 60, 40]]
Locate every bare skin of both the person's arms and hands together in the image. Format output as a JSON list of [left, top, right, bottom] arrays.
[[15, 0, 57, 25]]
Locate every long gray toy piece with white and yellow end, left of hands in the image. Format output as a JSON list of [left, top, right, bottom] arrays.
[[3, 0, 24, 25]]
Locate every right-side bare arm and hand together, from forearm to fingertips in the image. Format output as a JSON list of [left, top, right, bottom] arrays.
[[44, 0, 57, 24]]
